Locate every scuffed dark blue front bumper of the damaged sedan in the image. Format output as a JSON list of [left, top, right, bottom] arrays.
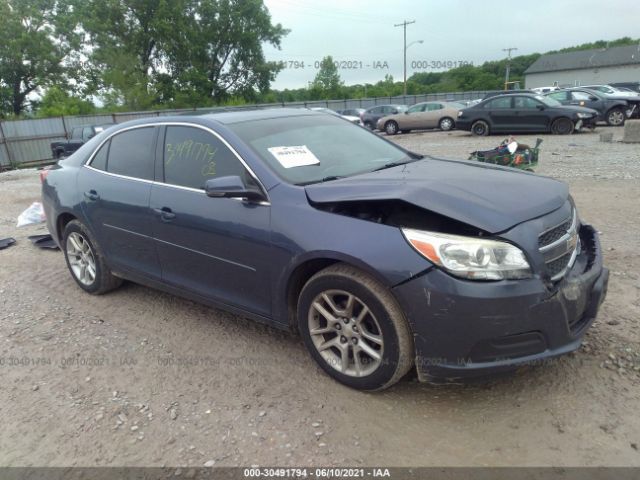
[[394, 225, 609, 382]]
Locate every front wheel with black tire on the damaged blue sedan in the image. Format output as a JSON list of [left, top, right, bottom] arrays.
[[297, 264, 414, 391]]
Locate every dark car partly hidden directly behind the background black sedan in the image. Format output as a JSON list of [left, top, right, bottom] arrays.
[[546, 88, 629, 126]]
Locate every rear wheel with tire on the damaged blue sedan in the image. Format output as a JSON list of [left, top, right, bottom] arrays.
[[62, 220, 122, 295]]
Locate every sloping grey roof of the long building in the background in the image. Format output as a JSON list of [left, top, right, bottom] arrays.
[[524, 45, 640, 75]]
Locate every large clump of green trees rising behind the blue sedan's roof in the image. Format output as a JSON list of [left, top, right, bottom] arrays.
[[68, 0, 288, 109]]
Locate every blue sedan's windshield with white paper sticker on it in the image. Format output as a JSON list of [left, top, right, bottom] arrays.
[[229, 115, 413, 185]]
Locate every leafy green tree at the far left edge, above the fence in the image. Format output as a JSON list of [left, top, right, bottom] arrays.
[[0, 0, 75, 115]]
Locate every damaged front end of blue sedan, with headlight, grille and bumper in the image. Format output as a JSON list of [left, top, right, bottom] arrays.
[[309, 179, 608, 383]]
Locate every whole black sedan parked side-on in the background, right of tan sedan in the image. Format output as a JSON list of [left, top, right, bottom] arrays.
[[456, 94, 598, 135]]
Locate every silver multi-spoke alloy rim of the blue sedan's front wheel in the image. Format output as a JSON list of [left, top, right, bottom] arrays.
[[308, 290, 384, 377]]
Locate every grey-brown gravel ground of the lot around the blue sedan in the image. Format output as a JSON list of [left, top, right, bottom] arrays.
[[0, 128, 640, 466]]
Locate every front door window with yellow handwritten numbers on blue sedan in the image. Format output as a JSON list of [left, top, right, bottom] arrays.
[[164, 126, 249, 189]]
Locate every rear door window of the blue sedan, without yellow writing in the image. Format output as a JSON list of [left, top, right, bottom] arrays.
[[107, 127, 154, 180]]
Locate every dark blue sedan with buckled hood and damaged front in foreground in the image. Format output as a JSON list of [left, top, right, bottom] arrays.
[[42, 109, 608, 390]]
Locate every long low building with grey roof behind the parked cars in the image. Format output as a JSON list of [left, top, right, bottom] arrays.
[[524, 44, 640, 88]]
